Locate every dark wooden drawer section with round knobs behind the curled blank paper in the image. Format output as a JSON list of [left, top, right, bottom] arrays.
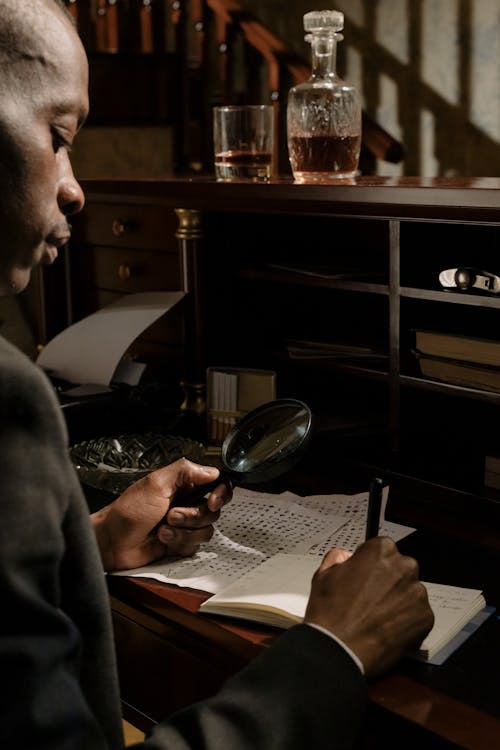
[[69, 195, 185, 383]]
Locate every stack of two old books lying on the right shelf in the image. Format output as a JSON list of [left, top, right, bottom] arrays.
[[415, 330, 500, 392]]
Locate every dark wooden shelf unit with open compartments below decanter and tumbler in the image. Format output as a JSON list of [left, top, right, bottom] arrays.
[[71, 177, 500, 547]]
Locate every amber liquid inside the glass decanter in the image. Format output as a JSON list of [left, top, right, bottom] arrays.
[[288, 135, 361, 182]]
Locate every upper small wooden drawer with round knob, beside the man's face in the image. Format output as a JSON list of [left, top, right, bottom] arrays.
[[72, 199, 177, 251]]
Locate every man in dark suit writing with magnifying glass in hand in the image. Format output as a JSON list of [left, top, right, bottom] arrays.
[[0, 0, 433, 750]]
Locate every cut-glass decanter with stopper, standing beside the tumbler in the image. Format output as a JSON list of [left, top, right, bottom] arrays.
[[287, 10, 361, 182]]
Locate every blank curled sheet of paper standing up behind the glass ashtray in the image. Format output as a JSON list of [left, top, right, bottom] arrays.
[[37, 292, 185, 386]]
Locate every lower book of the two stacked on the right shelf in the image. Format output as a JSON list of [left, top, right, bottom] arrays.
[[415, 352, 500, 392]]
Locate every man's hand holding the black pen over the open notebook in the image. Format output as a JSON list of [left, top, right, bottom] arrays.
[[305, 537, 434, 677]]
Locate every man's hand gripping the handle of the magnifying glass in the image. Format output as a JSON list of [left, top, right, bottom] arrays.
[[91, 458, 232, 570]]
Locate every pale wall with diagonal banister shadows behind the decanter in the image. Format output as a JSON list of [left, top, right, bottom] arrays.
[[247, 0, 500, 177]]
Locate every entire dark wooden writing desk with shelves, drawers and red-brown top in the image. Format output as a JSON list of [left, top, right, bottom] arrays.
[[64, 177, 500, 750]]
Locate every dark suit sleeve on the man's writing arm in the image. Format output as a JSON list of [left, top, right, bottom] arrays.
[[144, 625, 367, 750]]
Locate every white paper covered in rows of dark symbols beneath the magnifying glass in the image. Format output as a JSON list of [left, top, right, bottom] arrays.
[[114, 487, 414, 593]]
